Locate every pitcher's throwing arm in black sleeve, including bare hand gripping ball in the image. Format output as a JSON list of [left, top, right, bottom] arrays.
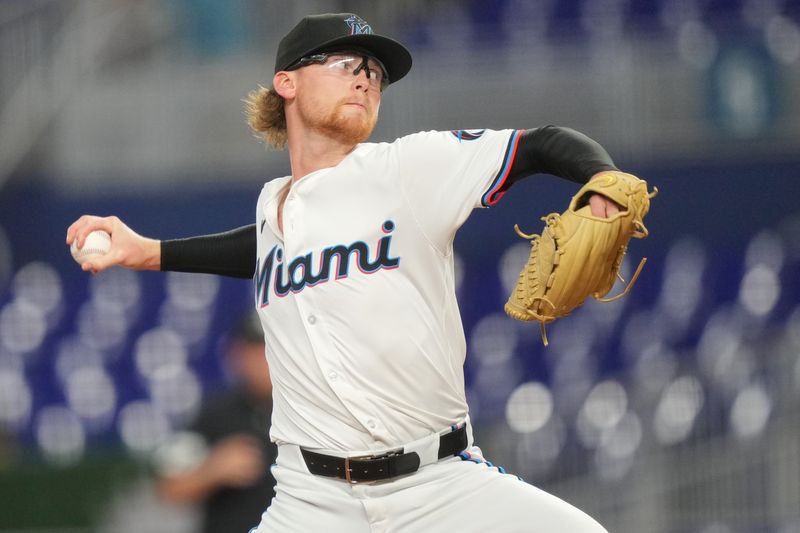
[[67, 215, 256, 279]]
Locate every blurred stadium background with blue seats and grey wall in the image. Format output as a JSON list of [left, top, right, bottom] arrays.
[[0, 0, 800, 533]]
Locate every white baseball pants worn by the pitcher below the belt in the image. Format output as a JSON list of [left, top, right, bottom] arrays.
[[251, 445, 607, 533]]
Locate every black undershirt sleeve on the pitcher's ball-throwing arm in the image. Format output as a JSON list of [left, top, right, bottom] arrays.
[[161, 224, 256, 278]]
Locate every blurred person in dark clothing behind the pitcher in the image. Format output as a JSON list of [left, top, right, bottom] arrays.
[[154, 312, 276, 533]]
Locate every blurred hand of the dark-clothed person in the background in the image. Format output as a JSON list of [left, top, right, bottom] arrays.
[[204, 435, 267, 487]]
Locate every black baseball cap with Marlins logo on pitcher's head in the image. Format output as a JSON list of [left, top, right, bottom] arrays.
[[275, 13, 411, 83]]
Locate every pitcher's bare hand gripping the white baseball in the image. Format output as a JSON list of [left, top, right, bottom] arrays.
[[67, 215, 161, 274]]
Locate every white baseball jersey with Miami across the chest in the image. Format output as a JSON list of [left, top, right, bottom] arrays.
[[255, 130, 521, 452]]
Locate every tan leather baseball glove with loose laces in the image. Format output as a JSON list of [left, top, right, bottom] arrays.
[[505, 171, 658, 346]]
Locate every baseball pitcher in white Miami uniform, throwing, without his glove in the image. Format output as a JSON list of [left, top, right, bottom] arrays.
[[66, 13, 636, 533]]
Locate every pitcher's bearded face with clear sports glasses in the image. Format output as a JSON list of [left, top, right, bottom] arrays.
[[296, 54, 382, 144]]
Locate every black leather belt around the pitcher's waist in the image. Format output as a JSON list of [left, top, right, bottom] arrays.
[[300, 424, 467, 483]]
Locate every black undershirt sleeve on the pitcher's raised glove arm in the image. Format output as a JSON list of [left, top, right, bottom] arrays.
[[506, 126, 618, 192]]
